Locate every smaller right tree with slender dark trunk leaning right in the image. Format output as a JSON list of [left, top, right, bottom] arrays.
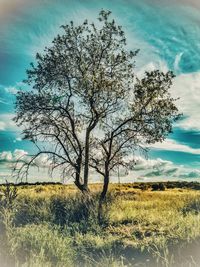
[[90, 70, 180, 222]]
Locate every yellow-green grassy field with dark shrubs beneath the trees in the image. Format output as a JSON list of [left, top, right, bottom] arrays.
[[0, 182, 200, 267]]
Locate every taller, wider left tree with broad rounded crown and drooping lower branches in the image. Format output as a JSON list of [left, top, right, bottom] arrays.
[[15, 10, 137, 191]]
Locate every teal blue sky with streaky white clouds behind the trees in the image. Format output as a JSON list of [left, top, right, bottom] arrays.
[[0, 0, 200, 182]]
